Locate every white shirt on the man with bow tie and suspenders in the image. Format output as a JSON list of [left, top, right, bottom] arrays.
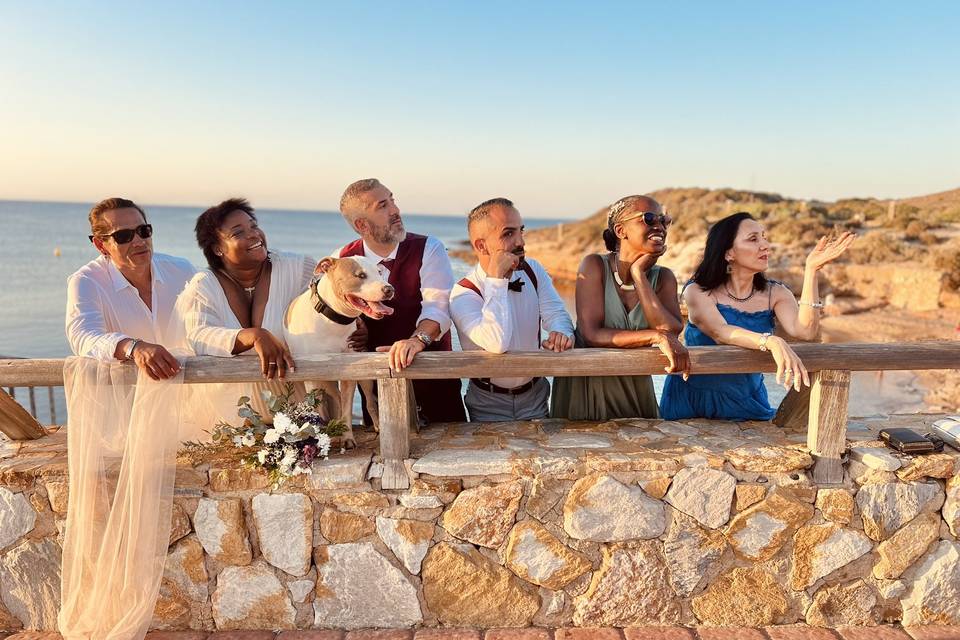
[[450, 258, 573, 389]]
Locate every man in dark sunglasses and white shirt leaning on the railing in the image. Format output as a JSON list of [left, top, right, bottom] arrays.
[[66, 198, 196, 380]]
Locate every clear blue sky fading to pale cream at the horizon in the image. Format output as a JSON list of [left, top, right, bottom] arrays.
[[0, 0, 960, 217]]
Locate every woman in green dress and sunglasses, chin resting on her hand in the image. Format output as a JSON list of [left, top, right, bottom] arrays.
[[551, 196, 690, 420]]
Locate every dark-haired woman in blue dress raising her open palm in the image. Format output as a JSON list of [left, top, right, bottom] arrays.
[[660, 212, 855, 420]]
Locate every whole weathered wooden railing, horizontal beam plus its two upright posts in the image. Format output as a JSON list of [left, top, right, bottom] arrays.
[[0, 341, 960, 489]]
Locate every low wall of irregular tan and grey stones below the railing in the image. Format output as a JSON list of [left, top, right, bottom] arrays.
[[0, 417, 960, 630]]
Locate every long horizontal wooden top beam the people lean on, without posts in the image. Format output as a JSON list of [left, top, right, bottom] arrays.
[[0, 340, 960, 387]]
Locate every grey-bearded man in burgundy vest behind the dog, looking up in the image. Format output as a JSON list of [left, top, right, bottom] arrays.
[[334, 178, 466, 422]]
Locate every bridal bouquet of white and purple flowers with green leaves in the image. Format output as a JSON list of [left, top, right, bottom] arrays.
[[211, 384, 346, 489]]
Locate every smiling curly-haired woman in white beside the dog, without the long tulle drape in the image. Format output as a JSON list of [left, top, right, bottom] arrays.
[[178, 198, 316, 426]]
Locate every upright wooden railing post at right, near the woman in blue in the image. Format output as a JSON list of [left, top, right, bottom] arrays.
[[807, 369, 850, 484]]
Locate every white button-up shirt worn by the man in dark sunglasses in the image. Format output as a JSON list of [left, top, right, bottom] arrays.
[[66, 253, 196, 360]]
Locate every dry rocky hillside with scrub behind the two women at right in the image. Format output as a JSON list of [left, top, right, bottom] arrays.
[[512, 188, 960, 309]]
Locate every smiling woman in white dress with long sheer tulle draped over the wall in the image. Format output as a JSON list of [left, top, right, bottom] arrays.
[[59, 199, 314, 640]]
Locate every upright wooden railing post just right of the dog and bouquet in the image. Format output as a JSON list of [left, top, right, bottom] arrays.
[[377, 378, 417, 489]]
